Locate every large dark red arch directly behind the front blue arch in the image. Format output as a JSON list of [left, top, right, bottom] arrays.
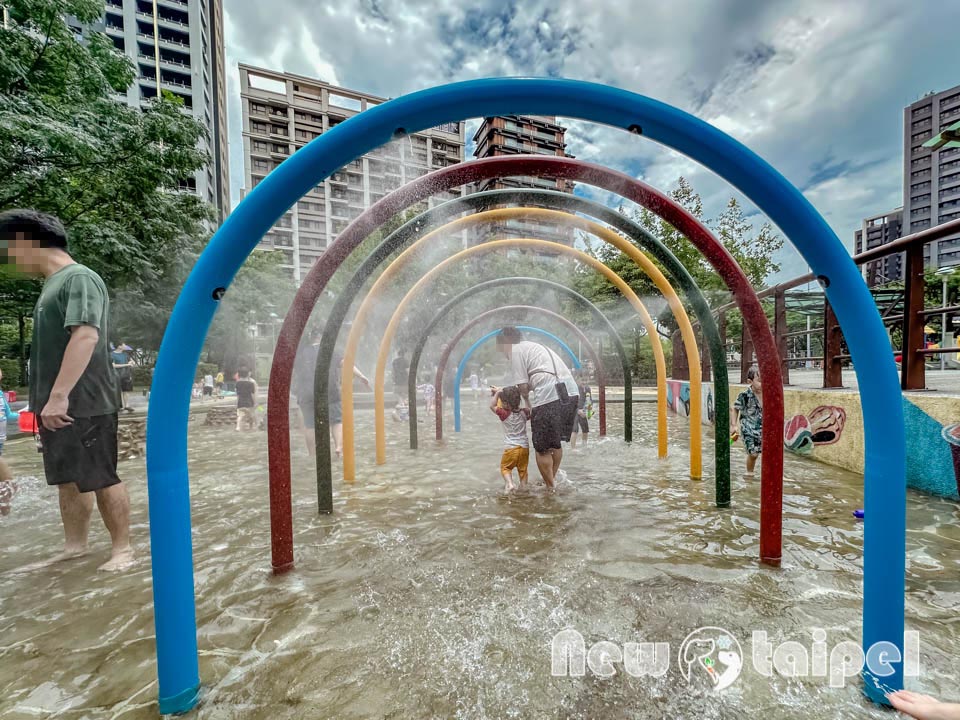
[[267, 156, 783, 571]]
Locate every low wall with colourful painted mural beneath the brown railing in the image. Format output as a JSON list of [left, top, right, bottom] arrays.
[[667, 380, 960, 499]]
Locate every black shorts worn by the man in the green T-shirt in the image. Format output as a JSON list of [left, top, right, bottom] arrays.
[[40, 413, 120, 492]]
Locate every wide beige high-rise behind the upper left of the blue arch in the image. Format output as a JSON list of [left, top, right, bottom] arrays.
[[240, 65, 464, 282]]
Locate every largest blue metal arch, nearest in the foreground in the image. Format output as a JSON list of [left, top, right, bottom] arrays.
[[147, 78, 906, 713]]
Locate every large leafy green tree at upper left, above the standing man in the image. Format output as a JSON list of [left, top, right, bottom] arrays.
[[0, 0, 212, 288]]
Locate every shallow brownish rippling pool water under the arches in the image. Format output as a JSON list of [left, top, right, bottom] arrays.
[[0, 399, 960, 720]]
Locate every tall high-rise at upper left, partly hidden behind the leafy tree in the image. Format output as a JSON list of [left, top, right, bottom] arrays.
[[80, 0, 230, 220]]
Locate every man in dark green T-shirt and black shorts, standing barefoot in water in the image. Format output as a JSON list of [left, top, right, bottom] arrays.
[[0, 210, 134, 570]]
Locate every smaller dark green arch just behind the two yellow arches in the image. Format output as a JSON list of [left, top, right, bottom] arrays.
[[404, 277, 633, 450]]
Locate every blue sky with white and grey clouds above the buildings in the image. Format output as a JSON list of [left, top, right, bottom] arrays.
[[224, 0, 960, 277]]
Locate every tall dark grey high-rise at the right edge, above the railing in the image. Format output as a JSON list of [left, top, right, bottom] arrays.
[[903, 86, 960, 268]]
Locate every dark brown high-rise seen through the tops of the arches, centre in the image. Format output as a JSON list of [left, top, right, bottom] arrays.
[[473, 115, 574, 245]]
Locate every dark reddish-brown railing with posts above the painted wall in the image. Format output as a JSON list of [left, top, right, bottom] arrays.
[[672, 220, 960, 390]]
